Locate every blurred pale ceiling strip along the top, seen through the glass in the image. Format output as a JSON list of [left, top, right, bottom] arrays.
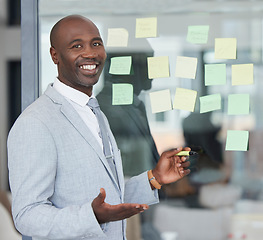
[[39, 0, 263, 16]]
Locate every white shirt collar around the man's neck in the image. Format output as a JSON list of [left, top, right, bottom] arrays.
[[53, 78, 94, 107]]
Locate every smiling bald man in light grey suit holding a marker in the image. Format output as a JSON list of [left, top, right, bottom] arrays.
[[8, 15, 190, 240]]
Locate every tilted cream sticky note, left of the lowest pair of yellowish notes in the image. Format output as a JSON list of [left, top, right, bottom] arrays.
[[149, 89, 172, 113]]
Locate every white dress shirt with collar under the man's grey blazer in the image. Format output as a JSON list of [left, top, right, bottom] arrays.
[[53, 78, 103, 149]]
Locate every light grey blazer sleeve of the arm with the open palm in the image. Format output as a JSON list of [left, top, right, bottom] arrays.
[[8, 116, 105, 239]]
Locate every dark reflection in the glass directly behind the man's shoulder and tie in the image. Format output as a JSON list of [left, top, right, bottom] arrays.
[[97, 51, 159, 177]]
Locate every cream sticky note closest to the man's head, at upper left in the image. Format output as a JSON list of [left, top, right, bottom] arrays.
[[106, 28, 129, 47]]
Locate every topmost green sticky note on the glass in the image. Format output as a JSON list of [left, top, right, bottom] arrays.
[[186, 25, 209, 44]]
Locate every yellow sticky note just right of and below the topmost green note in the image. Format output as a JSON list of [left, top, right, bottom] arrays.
[[215, 38, 237, 59]]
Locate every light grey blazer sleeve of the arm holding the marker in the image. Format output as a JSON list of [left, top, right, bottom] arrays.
[[124, 171, 159, 205]]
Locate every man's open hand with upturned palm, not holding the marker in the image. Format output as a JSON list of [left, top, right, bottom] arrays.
[[91, 188, 149, 224]]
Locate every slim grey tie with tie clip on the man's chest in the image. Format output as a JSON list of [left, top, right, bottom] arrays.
[[88, 98, 118, 181]]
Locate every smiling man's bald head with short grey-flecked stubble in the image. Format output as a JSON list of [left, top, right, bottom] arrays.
[[50, 15, 107, 95]]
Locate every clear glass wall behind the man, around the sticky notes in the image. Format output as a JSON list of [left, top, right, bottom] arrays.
[[39, 0, 263, 240]]
